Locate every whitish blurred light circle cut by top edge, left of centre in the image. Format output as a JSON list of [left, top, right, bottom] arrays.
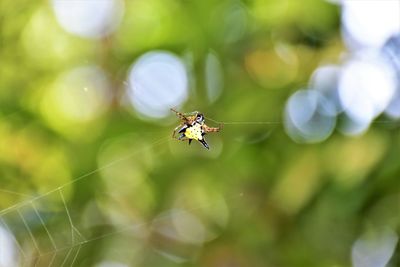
[[52, 0, 124, 38]]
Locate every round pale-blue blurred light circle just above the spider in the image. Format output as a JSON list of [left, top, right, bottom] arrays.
[[127, 51, 188, 118]]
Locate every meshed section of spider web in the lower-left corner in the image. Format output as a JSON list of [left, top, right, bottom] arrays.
[[0, 189, 87, 266]]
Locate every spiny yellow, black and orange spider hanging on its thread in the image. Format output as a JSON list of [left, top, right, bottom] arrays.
[[171, 108, 222, 149]]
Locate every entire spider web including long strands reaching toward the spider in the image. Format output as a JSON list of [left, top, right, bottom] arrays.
[[0, 118, 395, 266]]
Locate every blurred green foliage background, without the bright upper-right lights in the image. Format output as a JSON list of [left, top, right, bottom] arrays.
[[0, 0, 400, 267]]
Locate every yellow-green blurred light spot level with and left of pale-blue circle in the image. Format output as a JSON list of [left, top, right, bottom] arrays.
[[41, 66, 112, 138]]
